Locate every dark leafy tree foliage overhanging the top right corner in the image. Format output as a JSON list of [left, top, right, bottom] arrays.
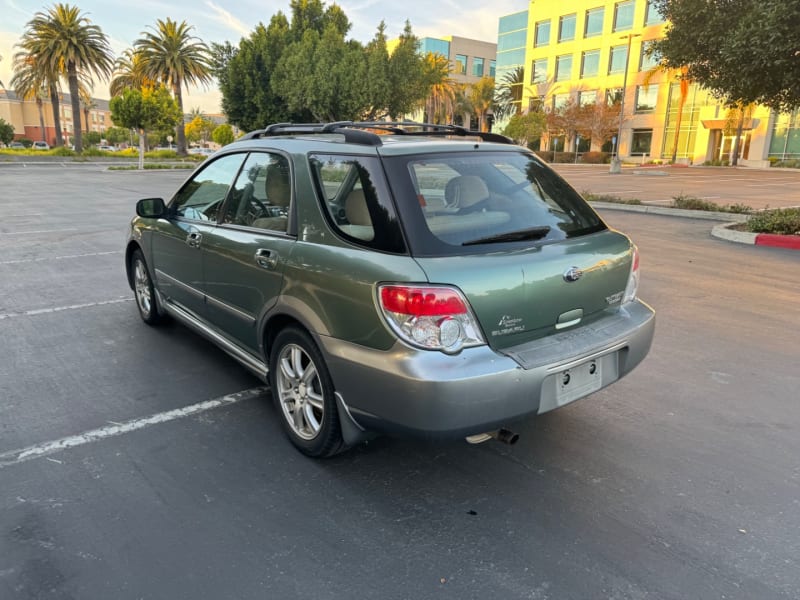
[[655, 0, 800, 111]]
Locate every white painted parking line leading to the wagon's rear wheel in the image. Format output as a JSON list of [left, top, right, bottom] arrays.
[[0, 387, 269, 469]]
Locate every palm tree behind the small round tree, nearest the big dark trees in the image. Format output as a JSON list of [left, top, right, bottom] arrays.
[[134, 18, 212, 155]]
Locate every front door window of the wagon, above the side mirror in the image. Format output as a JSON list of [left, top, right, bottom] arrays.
[[170, 154, 247, 221]]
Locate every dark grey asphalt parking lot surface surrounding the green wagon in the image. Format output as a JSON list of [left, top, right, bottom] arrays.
[[0, 165, 800, 600]]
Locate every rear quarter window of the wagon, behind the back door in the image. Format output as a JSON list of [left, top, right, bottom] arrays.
[[310, 154, 405, 253]]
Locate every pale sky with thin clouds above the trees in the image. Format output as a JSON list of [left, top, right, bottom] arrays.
[[0, 0, 528, 114]]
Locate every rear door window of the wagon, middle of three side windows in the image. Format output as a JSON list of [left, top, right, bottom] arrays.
[[222, 152, 292, 233]]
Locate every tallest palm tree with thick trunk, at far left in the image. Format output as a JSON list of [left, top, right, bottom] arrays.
[[21, 4, 113, 152]]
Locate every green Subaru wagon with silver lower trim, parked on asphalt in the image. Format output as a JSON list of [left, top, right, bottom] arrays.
[[125, 122, 655, 456]]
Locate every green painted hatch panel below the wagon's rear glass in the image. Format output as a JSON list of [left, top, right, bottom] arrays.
[[417, 230, 632, 349]]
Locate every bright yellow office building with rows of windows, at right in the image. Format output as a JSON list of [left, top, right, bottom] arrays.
[[514, 0, 788, 166]]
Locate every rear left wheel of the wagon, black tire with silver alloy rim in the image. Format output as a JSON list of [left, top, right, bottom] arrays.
[[269, 326, 345, 458]]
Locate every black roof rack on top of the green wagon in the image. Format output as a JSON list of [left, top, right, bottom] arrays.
[[240, 121, 513, 146]]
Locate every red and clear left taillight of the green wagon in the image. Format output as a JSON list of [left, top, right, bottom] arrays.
[[378, 285, 485, 354]]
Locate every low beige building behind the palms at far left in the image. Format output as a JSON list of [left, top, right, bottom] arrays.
[[0, 89, 113, 146]]
